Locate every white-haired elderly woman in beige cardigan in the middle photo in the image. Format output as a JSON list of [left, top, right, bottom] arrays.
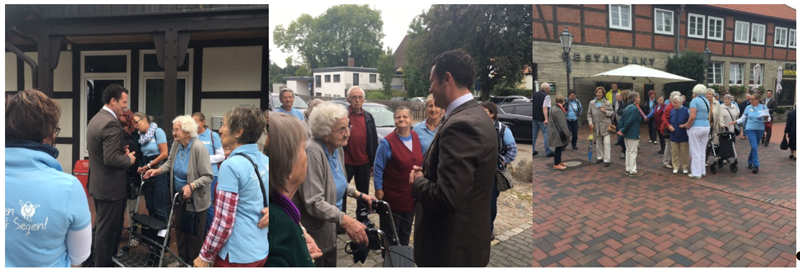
[[292, 102, 377, 267]]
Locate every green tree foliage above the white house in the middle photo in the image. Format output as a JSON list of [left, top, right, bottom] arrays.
[[272, 4, 384, 69]]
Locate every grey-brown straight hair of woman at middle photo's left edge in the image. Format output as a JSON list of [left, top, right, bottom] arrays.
[[269, 112, 308, 193]]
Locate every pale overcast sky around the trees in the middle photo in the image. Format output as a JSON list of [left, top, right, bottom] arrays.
[[269, 1, 430, 67]]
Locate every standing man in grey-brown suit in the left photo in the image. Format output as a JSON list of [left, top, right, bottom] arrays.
[[86, 84, 136, 267]]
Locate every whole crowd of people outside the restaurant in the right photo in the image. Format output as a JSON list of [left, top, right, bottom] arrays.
[[533, 83, 796, 179]]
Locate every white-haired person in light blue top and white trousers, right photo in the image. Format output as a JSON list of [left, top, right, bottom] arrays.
[[680, 84, 711, 179]]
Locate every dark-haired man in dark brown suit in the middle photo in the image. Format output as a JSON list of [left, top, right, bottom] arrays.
[[409, 50, 497, 266]]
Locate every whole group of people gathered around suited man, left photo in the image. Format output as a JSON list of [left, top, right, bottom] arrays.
[[5, 87, 269, 267]]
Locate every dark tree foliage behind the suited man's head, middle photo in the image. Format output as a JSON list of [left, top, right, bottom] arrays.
[[406, 5, 533, 100]]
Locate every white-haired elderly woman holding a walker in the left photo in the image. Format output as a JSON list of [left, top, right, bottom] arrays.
[[144, 115, 214, 266]]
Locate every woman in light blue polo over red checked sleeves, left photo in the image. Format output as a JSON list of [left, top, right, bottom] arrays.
[[194, 107, 269, 267]]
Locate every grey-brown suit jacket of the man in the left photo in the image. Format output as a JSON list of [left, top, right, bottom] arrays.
[[86, 109, 132, 201]]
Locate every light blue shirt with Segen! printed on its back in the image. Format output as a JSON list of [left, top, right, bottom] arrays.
[[5, 148, 92, 267]]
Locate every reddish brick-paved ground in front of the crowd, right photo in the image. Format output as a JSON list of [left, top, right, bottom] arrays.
[[533, 124, 796, 267]]
